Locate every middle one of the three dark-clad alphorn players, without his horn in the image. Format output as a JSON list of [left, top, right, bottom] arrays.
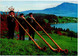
[[18, 13, 26, 40]]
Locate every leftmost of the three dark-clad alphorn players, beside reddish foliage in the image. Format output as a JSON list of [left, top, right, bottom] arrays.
[[7, 11, 15, 39]]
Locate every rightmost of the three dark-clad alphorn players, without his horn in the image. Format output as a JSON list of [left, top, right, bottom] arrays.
[[26, 13, 36, 40]]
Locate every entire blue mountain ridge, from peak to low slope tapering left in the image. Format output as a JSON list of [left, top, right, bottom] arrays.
[[21, 2, 78, 17]]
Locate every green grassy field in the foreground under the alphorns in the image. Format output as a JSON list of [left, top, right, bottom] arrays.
[[0, 31, 77, 55]]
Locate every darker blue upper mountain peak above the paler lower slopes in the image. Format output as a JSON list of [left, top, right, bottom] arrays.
[[45, 2, 78, 12]]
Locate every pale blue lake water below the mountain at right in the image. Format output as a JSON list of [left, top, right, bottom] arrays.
[[51, 23, 78, 33]]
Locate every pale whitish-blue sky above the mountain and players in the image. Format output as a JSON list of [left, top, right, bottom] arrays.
[[0, 0, 77, 11]]
